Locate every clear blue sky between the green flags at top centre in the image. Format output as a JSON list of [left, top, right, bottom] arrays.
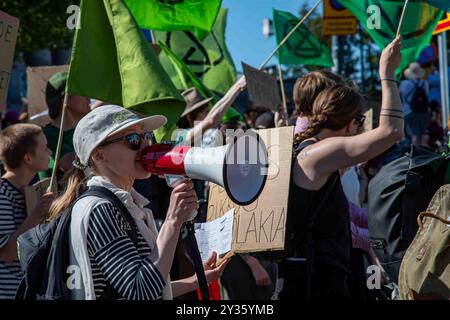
[[222, 0, 312, 71]]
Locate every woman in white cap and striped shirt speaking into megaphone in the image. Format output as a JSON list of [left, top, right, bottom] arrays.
[[50, 105, 226, 300]]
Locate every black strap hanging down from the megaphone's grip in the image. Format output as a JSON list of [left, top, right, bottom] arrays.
[[185, 222, 210, 300]]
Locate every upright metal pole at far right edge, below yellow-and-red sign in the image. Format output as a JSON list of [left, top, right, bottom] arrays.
[[438, 31, 449, 135]]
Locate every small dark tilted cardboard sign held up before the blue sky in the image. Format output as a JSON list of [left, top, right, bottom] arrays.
[[242, 63, 281, 111]]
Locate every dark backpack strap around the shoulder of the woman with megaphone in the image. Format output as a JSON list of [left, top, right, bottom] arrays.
[[78, 186, 138, 300]]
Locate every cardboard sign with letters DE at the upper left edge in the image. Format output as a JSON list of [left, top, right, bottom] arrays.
[[0, 11, 19, 112]]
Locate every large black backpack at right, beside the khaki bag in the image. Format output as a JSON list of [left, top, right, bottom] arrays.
[[368, 145, 450, 282]]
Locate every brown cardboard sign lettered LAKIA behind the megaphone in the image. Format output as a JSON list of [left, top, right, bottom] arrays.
[[207, 127, 294, 253]]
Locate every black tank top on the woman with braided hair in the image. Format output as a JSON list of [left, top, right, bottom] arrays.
[[288, 140, 351, 276]]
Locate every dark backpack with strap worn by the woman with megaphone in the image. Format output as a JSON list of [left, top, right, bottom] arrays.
[[16, 187, 137, 300]]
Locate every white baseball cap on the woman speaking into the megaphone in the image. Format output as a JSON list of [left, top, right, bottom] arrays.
[[73, 105, 167, 166]]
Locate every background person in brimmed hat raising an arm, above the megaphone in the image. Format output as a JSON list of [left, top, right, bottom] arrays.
[[174, 77, 247, 147]]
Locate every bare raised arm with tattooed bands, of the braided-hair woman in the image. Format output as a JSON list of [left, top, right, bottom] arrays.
[[297, 37, 403, 181]]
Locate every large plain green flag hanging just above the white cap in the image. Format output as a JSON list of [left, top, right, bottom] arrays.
[[67, 0, 185, 141]]
